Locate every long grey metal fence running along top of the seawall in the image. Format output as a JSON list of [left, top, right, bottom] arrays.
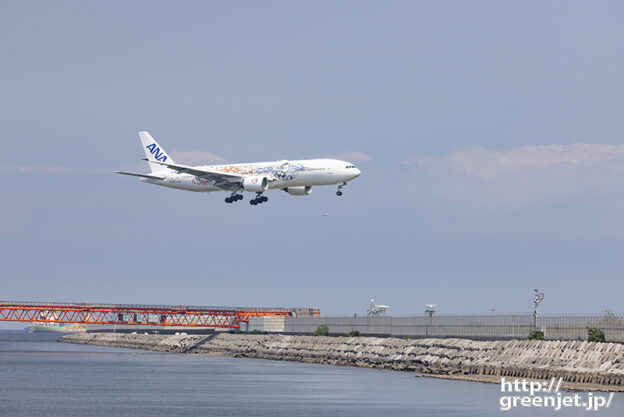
[[280, 313, 624, 343]]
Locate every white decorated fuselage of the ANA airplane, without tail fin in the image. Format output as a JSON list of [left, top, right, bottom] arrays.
[[142, 159, 360, 192]]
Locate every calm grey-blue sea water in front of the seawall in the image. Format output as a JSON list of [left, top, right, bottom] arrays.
[[0, 331, 624, 417]]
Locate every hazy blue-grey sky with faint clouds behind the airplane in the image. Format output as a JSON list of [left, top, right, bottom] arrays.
[[0, 1, 624, 320]]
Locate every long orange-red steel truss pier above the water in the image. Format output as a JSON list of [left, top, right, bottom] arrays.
[[0, 301, 320, 328]]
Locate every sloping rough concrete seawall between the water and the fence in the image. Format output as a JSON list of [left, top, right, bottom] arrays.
[[59, 333, 624, 391]]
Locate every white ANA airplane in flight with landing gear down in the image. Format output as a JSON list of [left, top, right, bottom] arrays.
[[115, 131, 360, 206]]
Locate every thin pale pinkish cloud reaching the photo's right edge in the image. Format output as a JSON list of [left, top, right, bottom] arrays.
[[408, 144, 624, 208]]
